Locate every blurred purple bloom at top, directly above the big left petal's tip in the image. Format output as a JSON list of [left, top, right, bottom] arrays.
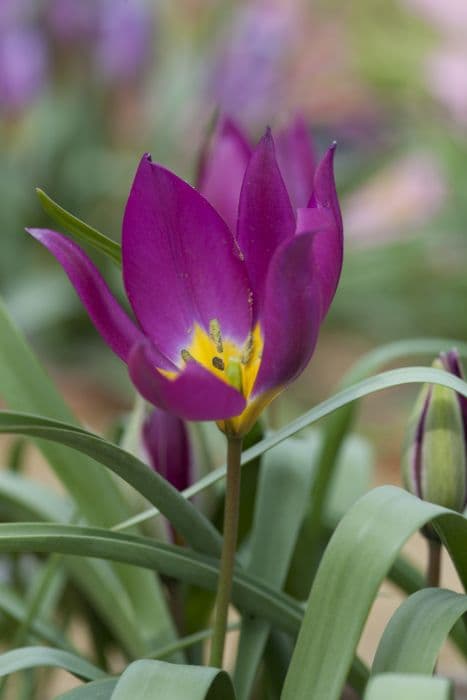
[[95, 0, 154, 82]]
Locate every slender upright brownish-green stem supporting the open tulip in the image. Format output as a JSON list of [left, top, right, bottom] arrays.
[[209, 436, 242, 668]]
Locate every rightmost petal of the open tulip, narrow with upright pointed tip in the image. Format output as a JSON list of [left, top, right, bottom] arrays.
[[297, 146, 344, 318]]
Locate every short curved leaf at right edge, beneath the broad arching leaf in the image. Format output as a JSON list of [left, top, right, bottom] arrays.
[[372, 588, 467, 674]]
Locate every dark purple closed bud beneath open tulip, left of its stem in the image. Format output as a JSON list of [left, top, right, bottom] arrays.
[[142, 408, 192, 491]]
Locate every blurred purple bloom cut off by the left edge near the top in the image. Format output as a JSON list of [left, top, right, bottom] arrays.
[[0, 22, 48, 112]]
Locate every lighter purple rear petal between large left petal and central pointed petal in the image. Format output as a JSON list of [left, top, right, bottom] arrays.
[[198, 117, 252, 234]]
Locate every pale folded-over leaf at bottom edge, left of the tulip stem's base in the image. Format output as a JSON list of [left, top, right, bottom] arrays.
[[112, 660, 235, 700]]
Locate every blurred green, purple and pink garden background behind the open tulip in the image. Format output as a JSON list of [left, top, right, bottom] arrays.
[[0, 0, 467, 396]]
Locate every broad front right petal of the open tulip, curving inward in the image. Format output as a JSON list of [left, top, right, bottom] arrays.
[[252, 233, 321, 397]]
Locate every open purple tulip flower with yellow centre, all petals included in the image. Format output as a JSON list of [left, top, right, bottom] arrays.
[[30, 123, 343, 435]]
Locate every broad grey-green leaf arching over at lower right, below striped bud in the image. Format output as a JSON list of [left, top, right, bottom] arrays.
[[282, 486, 467, 700]]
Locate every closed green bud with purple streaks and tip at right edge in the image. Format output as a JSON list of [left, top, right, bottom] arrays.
[[402, 350, 466, 511]]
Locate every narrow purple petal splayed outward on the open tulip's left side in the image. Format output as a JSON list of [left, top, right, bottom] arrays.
[[26, 228, 144, 362]]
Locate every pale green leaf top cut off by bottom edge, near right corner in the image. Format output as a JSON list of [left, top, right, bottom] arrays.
[[364, 673, 454, 700]]
